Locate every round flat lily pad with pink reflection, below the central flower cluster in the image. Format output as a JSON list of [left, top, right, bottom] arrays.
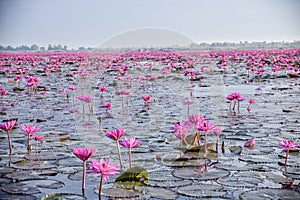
[[173, 166, 230, 181]]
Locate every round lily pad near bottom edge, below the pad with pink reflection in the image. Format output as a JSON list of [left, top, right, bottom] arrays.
[[178, 184, 227, 198]]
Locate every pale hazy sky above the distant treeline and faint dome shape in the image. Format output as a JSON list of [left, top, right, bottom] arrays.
[[0, 0, 300, 48]]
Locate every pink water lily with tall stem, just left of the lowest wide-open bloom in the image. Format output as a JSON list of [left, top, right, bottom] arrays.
[[73, 147, 97, 190]]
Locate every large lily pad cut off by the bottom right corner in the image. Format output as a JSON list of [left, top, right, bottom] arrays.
[[240, 189, 300, 200]]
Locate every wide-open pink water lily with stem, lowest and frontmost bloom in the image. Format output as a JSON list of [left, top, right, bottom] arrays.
[[89, 158, 120, 196]]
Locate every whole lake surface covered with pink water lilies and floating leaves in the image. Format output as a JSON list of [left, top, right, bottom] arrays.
[[0, 49, 300, 200]]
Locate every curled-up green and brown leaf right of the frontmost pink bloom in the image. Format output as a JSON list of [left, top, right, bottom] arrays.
[[116, 167, 148, 182]]
